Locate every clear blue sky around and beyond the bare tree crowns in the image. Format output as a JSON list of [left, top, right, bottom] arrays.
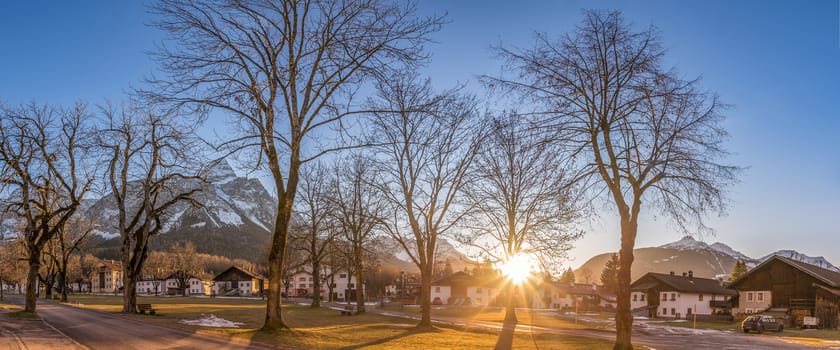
[[0, 0, 840, 267]]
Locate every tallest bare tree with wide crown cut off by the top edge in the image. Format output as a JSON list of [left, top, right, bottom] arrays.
[[150, 0, 442, 330]]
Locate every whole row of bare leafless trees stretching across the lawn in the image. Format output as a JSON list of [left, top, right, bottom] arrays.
[[0, 0, 739, 349]]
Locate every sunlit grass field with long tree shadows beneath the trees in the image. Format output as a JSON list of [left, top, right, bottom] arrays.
[[64, 295, 612, 349]]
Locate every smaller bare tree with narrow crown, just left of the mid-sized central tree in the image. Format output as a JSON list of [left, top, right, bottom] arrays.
[[331, 155, 385, 314]]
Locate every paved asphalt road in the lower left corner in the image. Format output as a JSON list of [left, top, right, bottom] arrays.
[[8, 300, 274, 350]]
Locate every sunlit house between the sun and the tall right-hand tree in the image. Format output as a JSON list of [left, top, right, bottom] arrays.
[[531, 282, 616, 311]]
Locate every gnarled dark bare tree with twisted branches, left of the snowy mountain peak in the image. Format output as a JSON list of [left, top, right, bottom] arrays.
[[99, 104, 204, 313]]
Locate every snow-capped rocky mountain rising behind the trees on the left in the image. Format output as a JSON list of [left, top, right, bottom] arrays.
[[87, 161, 276, 260]]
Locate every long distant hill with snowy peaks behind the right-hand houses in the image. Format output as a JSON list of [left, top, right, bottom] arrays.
[[575, 236, 840, 283]]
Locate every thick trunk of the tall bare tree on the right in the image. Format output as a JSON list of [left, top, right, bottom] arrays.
[[613, 217, 638, 350]]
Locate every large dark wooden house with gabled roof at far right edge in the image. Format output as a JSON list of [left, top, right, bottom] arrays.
[[730, 256, 840, 329]]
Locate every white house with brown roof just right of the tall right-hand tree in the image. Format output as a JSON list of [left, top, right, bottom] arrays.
[[630, 271, 738, 319]]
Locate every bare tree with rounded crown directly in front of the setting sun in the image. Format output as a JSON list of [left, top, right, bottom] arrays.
[[459, 113, 581, 322]]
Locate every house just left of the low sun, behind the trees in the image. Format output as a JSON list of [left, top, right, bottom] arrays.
[[430, 271, 501, 306]]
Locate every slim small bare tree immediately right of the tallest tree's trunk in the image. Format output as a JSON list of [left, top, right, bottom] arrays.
[[293, 163, 339, 307]]
